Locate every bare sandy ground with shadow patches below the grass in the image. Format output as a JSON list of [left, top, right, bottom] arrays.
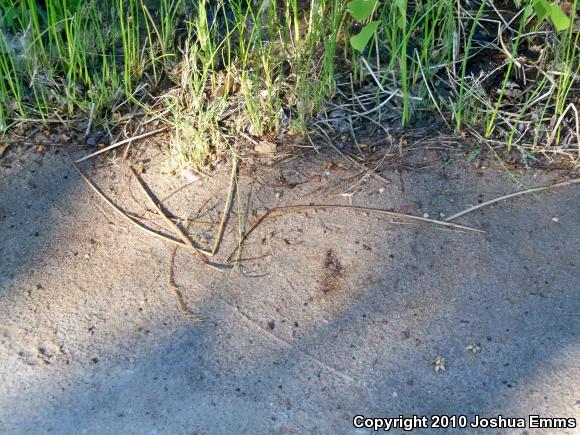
[[0, 141, 580, 434]]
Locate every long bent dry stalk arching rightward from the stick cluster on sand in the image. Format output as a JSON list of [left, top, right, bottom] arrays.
[[228, 204, 485, 262]]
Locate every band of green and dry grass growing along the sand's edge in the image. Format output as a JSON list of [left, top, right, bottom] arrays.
[[0, 0, 580, 165]]
